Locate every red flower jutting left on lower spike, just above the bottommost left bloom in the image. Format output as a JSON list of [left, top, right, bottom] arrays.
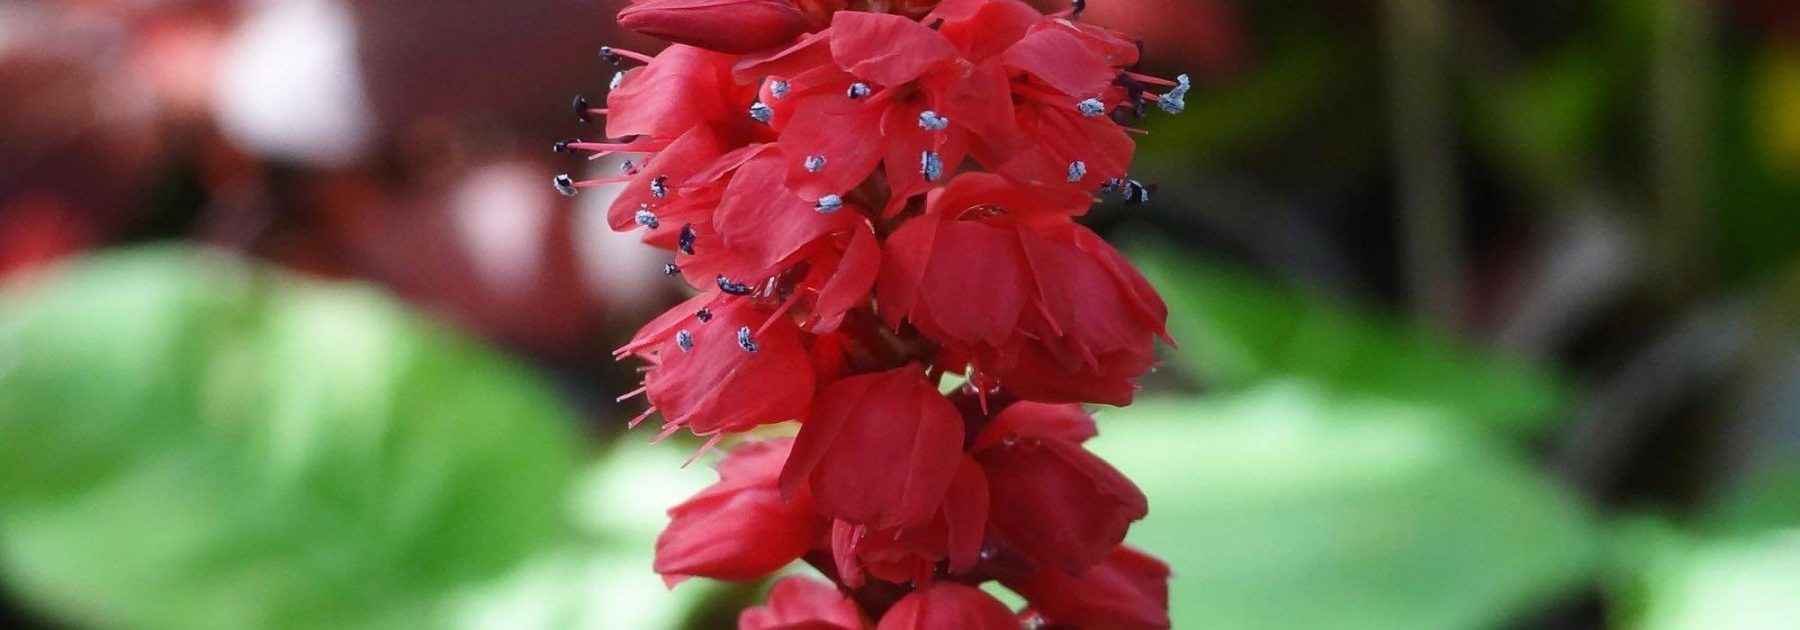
[[655, 439, 830, 587]]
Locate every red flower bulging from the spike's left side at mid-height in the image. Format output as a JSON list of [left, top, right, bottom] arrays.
[[634, 297, 814, 436]]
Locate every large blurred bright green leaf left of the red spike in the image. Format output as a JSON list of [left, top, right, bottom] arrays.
[[0, 248, 578, 628]]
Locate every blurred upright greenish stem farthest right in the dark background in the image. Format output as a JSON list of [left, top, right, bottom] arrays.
[[1647, 0, 1717, 302]]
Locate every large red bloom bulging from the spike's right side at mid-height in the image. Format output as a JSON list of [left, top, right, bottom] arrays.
[[877, 175, 1168, 405]]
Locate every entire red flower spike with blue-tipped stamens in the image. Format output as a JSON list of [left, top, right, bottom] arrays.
[[554, 0, 1188, 628]]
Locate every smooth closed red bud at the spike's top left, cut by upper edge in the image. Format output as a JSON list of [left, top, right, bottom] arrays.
[[619, 0, 808, 52]]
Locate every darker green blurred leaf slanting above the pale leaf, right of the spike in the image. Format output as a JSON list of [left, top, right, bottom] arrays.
[[1132, 247, 1566, 436]]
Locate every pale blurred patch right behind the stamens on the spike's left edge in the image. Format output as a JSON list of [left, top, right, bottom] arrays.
[[576, 157, 680, 320]]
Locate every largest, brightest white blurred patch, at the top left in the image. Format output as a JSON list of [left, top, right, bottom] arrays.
[[212, 0, 374, 167]]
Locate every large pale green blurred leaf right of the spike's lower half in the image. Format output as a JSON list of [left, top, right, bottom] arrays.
[[1093, 383, 1598, 630]]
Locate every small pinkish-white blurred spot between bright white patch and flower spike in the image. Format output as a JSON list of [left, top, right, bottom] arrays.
[[450, 164, 553, 295]]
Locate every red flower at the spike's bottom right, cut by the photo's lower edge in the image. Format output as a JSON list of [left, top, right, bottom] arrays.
[[1003, 545, 1170, 630]]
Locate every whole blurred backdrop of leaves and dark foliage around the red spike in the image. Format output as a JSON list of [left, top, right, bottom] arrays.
[[0, 0, 1800, 628]]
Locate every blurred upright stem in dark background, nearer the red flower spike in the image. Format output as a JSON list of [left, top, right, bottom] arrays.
[[1384, 0, 1467, 331]]
